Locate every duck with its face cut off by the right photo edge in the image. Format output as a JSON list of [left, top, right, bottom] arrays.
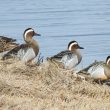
[[80, 56, 110, 81]]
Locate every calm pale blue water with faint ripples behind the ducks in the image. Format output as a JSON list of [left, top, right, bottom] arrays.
[[0, 0, 110, 67]]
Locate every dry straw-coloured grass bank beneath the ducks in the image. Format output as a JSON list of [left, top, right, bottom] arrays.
[[0, 60, 110, 110]]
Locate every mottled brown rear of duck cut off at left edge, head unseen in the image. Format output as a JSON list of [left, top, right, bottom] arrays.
[[0, 36, 19, 53]]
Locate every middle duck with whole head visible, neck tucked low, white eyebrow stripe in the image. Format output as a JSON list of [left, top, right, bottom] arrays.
[[47, 40, 84, 69]]
